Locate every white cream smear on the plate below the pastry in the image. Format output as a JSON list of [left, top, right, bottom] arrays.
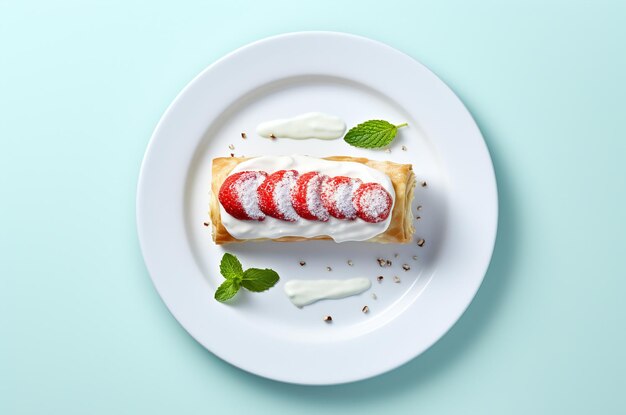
[[284, 278, 372, 307]]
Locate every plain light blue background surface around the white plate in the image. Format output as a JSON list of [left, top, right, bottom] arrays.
[[0, 0, 626, 415]]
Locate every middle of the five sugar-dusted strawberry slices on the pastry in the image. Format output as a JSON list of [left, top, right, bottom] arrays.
[[291, 171, 330, 222]]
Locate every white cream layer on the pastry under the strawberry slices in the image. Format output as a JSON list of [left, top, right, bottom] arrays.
[[220, 155, 396, 242]]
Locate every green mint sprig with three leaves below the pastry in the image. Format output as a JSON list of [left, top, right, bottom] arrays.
[[215, 253, 279, 301]]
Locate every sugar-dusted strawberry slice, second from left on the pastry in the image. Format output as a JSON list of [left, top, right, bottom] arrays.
[[257, 170, 298, 222]]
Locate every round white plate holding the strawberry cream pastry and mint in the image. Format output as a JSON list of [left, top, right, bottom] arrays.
[[137, 32, 497, 384]]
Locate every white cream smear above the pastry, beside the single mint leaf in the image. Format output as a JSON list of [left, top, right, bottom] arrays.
[[257, 112, 346, 140]]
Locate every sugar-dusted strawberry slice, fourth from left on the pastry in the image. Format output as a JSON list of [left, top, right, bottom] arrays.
[[321, 176, 362, 220]]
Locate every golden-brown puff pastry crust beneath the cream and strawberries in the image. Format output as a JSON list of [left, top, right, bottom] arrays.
[[209, 156, 415, 245]]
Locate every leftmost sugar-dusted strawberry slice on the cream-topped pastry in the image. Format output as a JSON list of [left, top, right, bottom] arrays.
[[217, 171, 267, 221]]
